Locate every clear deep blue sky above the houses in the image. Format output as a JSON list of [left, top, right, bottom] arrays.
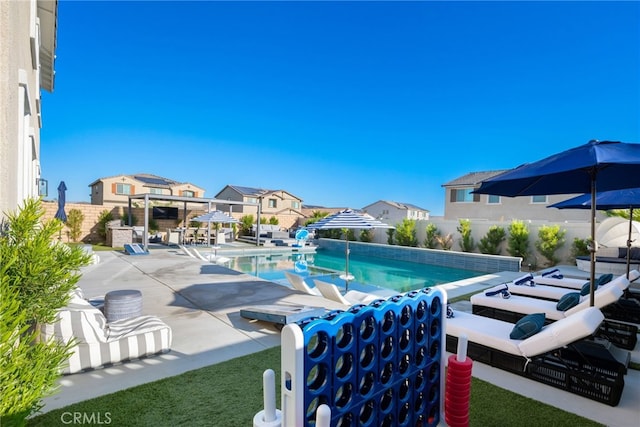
[[41, 0, 640, 215]]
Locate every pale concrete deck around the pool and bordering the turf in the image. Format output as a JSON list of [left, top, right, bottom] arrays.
[[37, 247, 640, 427]]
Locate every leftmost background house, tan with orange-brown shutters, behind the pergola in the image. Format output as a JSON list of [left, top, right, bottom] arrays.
[[89, 173, 205, 206]]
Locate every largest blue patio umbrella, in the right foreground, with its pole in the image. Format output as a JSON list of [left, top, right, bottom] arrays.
[[474, 141, 640, 306]]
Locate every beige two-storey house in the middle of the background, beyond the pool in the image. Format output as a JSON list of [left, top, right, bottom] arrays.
[[214, 185, 304, 228]]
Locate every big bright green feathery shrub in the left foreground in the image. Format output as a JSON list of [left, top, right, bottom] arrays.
[[0, 199, 91, 424]]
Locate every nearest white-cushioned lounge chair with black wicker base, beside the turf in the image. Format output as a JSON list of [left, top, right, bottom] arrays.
[[445, 307, 626, 406]]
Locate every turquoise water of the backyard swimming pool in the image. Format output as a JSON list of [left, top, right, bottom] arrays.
[[230, 251, 486, 292]]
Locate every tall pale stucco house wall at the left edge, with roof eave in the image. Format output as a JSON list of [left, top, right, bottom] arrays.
[[0, 0, 58, 216]]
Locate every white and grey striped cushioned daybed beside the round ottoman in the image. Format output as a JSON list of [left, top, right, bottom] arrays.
[[41, 290, 172, 374]]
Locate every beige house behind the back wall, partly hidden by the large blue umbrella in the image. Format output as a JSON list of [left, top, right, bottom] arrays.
[[442, 170, 590, 222]]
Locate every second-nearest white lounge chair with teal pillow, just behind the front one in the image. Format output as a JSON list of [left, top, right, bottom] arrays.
[[470, 278, 638, 352]]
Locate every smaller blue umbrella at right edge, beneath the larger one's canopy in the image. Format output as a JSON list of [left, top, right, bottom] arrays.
[[547, 188, 640, 278]]
